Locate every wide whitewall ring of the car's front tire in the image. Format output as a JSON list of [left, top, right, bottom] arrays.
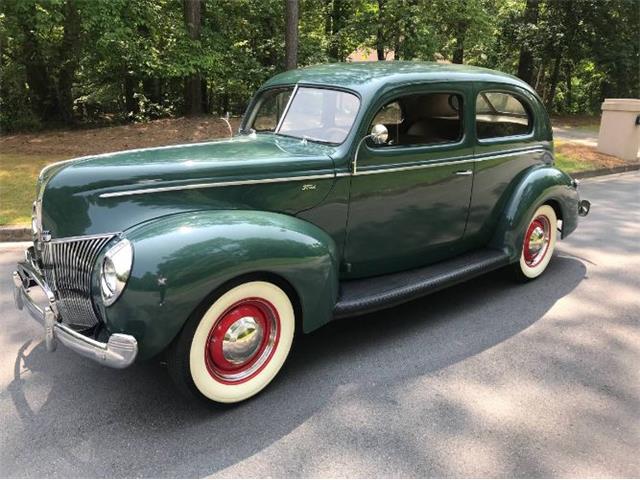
[[184, 281, 295, 403]]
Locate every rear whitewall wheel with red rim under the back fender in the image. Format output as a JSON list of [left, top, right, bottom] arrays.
[[514, 205, 558, 281]]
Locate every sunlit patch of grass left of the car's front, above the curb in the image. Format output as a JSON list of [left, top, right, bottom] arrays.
[[0, 154, 65, 225]]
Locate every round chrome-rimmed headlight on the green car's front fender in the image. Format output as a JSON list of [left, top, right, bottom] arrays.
[[100, 238, 133, 307]]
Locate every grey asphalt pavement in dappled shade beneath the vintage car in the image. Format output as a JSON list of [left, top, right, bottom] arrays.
[[0, 172, 640, 477]]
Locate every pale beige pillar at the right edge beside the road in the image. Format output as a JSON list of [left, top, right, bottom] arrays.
[[598, 98, 640, 161]]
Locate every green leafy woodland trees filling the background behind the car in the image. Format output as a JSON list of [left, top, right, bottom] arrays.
[[0, 0, 640, 131]]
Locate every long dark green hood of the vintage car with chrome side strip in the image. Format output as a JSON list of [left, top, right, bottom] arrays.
[[38, 134, 334, 238]]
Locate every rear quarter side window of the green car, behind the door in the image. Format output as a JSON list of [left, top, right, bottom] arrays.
[[476, 92, 533, 140]]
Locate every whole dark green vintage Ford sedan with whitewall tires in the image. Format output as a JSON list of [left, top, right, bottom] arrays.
[[13, 62, 589, 403]]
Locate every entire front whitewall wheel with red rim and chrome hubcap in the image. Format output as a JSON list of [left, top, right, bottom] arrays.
[[168, 281, 295, 403]]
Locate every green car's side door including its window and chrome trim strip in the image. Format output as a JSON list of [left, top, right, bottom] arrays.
[[345, 83, 474, 277]]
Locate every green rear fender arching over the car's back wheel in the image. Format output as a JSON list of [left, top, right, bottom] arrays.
[[489, 166, 579, 262]]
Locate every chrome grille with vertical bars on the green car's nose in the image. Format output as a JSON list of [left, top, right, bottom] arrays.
[[42, 234, 114, 328]]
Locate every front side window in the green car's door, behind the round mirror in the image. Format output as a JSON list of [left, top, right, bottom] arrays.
[[369, 93, 462, 148]]
